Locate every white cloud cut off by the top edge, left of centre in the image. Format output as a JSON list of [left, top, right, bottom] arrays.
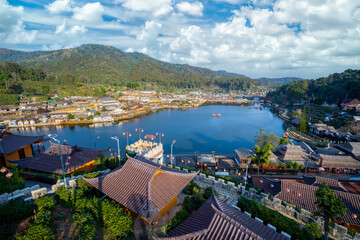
[[117, 0, 173, 16]]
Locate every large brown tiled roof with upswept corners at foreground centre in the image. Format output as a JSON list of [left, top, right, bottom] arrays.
[[84, 156, 197, 217]]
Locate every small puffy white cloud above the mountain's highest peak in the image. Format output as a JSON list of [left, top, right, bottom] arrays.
[[73, 2, 104, 24]]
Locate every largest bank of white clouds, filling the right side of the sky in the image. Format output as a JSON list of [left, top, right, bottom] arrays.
[[130, 0, 360, 77]]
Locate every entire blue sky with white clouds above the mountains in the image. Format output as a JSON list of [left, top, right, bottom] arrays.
[[0, 0, 360, 78]]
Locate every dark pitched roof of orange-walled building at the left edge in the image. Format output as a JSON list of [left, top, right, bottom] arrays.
[[0, 129, 44, 155]]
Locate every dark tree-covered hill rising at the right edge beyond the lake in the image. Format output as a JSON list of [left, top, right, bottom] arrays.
[[267, 69, 360, 104]]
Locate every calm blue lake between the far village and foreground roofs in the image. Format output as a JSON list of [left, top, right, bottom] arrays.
[[11, 105, 284, 154]]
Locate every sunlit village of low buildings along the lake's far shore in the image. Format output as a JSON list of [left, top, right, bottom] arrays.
[[0, 90, 266, 127]]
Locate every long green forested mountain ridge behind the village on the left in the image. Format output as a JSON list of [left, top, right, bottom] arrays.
[[0, 44, 253, 90]]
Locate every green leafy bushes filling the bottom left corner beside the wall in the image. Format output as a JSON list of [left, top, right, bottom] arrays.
[[0, 179, 134, 240]]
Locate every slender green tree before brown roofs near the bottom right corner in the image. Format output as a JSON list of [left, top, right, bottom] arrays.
[[315, 183, 347, 240]]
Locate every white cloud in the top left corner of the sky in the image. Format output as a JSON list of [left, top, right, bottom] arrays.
[[0, 0, 38, 44]]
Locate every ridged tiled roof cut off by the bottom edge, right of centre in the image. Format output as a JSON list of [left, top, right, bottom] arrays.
[[165, 194, 287, 240]]
